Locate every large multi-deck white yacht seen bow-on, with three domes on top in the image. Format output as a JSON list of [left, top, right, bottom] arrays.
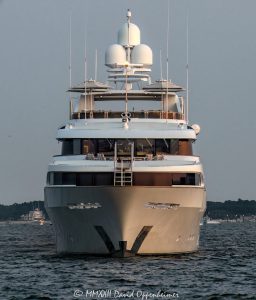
[[45, 10, 206, 257]]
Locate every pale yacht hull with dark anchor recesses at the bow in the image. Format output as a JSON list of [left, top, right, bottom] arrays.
[[45, 186, 205, 257]]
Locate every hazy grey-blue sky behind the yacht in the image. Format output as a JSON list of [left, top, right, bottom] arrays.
[[0, 0, 256, 204]]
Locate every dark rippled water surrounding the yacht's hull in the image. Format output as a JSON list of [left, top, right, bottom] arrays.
[[0, 223, 256, 300]]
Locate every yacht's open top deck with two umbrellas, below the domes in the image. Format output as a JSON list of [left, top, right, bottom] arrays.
[[69, 80, 185, 121]]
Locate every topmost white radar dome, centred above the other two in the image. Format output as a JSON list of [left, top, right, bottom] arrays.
[[117, 23, 140, 46]]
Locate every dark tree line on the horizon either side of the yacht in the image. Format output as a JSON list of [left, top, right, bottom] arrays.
[[0, 198, 256, 221]]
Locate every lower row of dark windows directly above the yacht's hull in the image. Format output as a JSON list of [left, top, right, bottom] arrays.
[[47, 172, 201, 186]]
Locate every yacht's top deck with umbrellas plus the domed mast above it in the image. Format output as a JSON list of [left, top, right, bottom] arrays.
[[68, 11, 187, 124]]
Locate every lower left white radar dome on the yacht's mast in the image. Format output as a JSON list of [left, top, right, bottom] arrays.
[[105, 44, 126, 67]]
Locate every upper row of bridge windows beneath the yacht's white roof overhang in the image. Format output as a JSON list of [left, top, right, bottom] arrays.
[[61, 139, 192, 156]]
